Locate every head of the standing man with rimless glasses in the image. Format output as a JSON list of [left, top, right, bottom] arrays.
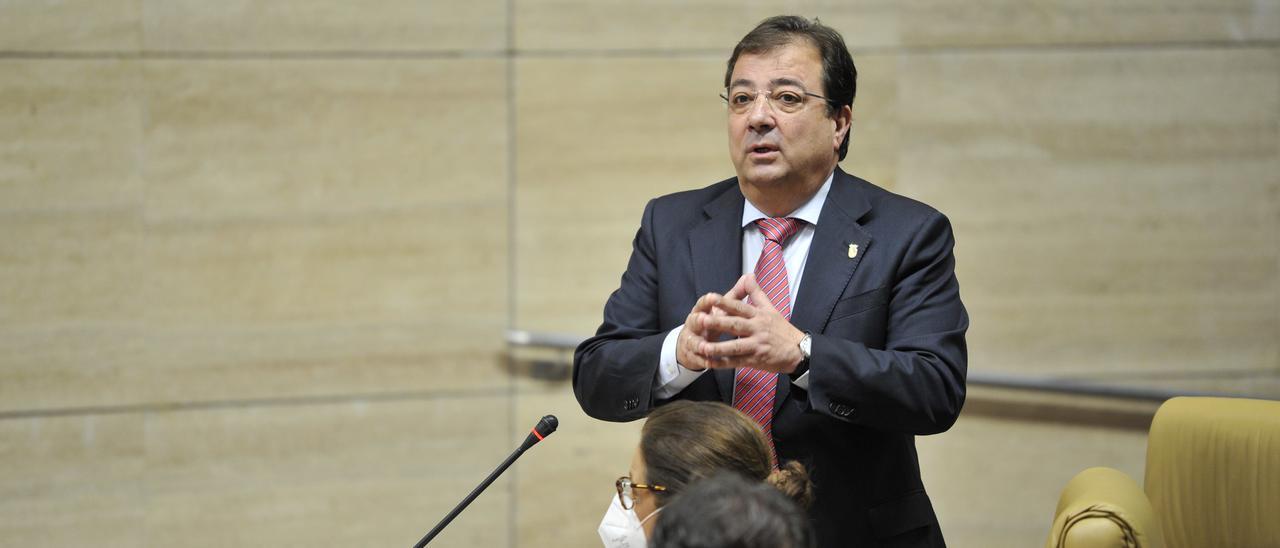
[[724, 15, 858, 207]]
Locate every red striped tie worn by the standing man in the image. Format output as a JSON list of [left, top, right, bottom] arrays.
[[733, 218, 804, 463]]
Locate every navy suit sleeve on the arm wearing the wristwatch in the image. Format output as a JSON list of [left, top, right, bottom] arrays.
[[808, 211, 969, 435]]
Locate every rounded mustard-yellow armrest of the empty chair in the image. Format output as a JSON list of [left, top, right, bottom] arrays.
[[1044, 467, 1165, 548]]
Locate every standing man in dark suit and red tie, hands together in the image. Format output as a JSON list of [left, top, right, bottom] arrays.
[[573, 17, 969, 547]]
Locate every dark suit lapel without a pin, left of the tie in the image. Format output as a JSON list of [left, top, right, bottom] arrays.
[[689, 184, 745, 405]]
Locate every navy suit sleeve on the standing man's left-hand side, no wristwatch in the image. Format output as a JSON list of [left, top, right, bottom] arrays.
[[573, 201, 666, 421]]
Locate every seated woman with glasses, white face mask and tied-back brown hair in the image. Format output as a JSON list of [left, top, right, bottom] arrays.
[[599, 401, 813, 548]]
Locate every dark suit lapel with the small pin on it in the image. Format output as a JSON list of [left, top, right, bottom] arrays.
[[773, 168, 872, 414]]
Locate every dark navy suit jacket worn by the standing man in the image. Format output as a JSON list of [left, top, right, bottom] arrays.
[[573, 168, 969, 547]]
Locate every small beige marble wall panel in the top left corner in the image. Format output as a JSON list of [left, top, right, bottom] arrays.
[[0, 0, 142, 52]]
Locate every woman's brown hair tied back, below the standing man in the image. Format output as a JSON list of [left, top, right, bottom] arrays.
[[640, 401, 813, 507]]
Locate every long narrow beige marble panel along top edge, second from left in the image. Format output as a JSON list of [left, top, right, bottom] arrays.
[[142, 0, 507, 54]]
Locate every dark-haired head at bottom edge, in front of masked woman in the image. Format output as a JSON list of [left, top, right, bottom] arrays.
[[649, 472, 814, 548]]
